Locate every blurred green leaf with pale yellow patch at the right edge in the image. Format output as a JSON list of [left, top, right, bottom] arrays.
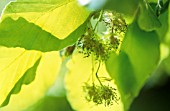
[[156, 5, 170, 74]]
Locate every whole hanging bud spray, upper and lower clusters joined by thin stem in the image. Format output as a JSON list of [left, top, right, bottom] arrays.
[[76, 11, 127, 106]]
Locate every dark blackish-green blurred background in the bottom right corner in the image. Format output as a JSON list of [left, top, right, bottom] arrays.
[[129, 73, 170, 111]]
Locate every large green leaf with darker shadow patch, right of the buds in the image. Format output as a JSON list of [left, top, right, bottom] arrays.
[[106, 22, 159, 110]]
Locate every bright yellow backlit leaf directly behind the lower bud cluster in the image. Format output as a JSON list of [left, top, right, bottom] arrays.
[[65, 54, 123, 111]]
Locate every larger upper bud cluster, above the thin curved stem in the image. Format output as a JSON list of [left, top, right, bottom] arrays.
[[77, 11, 127, 61]]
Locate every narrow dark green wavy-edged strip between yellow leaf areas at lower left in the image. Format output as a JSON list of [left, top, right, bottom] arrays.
[[0, 59, 40, 107]]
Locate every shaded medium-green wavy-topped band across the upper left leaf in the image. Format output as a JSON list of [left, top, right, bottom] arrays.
[[0, 18, 85, 52]]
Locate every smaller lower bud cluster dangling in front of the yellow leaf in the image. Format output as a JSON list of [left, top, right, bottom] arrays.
[[83, 83, 120, 106]]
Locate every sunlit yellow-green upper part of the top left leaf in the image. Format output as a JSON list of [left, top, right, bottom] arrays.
[[2, 0, 89, 39]]
